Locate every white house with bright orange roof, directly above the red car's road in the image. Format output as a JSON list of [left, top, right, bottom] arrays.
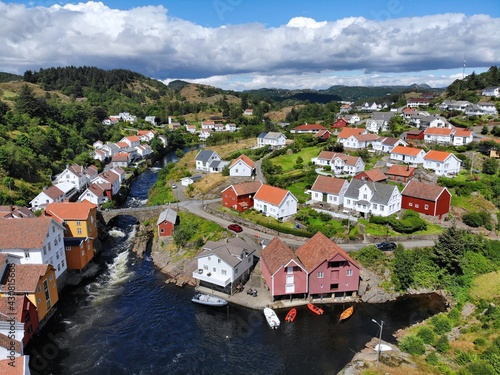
[[253, 184, 298, 220]]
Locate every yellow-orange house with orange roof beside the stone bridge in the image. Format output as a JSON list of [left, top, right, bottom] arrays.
[[45, 200, 97, 270]]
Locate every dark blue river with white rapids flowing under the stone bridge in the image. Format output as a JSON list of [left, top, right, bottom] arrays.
[[27, 148, 444, 375]]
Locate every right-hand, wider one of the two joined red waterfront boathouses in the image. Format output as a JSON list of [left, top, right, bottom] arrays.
[[294, 232, 360, 296]]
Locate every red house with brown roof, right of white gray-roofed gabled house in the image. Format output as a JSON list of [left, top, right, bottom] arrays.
[[401, 180, 451, 219]]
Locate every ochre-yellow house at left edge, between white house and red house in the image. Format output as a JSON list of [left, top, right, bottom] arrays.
[[0, 264, 59, 322]]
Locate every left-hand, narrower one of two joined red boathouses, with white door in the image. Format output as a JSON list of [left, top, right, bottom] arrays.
[[260, 237, 307, 299]]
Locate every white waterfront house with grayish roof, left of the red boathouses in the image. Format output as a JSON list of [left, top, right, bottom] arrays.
[[193, 237, 257, 295]]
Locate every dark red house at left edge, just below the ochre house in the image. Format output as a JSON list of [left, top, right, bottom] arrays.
[[0, 296, 38, 347]]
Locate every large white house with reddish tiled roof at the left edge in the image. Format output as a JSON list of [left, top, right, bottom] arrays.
[[0, 216, 68, 278]]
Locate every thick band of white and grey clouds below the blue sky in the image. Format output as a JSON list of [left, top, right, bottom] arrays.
[[0, 2, 500, 89]]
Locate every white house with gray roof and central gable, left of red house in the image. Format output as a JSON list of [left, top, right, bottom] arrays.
[[344, 179, 402, 217]]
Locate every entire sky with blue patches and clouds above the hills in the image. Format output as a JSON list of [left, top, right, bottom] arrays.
[[0, 0, 500, 91]]
